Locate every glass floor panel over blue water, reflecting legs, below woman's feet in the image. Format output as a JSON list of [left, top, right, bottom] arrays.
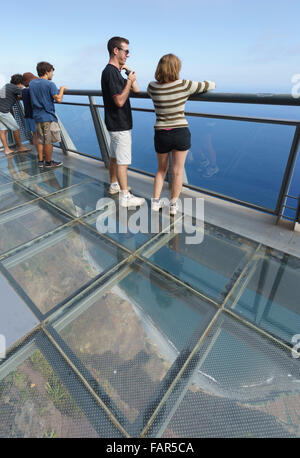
[[142, 221, 258, 303]]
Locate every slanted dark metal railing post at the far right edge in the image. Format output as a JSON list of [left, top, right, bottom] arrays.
[[275, 126, 300, 224]]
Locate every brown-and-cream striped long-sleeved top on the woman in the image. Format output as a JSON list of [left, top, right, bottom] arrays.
[[147, 80, 216, 129]]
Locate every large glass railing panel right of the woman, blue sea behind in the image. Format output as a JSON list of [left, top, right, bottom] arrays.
[[185, 117, 295, 210]]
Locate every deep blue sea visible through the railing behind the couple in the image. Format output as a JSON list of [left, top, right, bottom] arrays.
[[57, 97, 300, 217]]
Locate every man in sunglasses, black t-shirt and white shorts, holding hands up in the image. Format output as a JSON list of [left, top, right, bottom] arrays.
[[101, 37, 145, 207]]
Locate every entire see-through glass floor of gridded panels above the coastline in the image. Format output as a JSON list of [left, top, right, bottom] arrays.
[[0, 159, 300, 438]]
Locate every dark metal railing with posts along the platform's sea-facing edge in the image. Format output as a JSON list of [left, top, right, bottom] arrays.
[[53, 89, 300, 223]]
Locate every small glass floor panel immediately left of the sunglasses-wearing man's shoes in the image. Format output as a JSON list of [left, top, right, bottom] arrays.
[[47, 180, 108, 217]]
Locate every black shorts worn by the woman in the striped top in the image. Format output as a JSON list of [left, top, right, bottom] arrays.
[[154, 127, 191, 154]]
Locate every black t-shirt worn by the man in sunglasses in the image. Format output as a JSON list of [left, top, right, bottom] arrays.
[[101, 64, 132, 132]]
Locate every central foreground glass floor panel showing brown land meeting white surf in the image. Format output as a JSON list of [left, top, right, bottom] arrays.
[[54, 262, 216, 434]]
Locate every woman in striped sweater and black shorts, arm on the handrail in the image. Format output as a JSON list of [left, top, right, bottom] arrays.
[[147, 54, 216, 215]]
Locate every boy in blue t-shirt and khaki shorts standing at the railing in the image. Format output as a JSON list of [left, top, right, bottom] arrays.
[[29, 62, 66, 168]]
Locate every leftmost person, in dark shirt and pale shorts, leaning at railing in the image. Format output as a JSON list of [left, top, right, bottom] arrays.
[[0, 74, 31, 154]]
